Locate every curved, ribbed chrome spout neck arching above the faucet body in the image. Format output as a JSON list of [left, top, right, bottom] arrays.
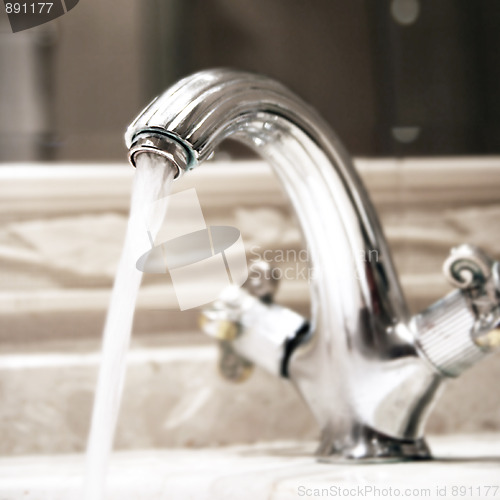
[[126, 70, 408, 332]]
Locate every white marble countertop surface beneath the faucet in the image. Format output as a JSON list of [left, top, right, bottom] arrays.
[[0, 434, 500, 500]]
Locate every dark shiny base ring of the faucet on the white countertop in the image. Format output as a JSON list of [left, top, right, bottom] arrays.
[[316, 425, 432, 463]]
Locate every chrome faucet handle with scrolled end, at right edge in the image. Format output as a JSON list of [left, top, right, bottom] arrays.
[[413, 245, 500, 377]]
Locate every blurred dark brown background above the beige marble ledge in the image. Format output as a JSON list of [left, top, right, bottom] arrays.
[[0, 0, 500, 161]]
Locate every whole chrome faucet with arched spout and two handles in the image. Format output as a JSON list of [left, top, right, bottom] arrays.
[[126, 69, 500, 461]]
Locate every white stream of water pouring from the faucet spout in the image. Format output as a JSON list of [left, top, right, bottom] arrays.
[[83, 153, 175, 500]]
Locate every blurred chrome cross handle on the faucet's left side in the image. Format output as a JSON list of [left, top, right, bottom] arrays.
[[200, 260, 309, 382]]
